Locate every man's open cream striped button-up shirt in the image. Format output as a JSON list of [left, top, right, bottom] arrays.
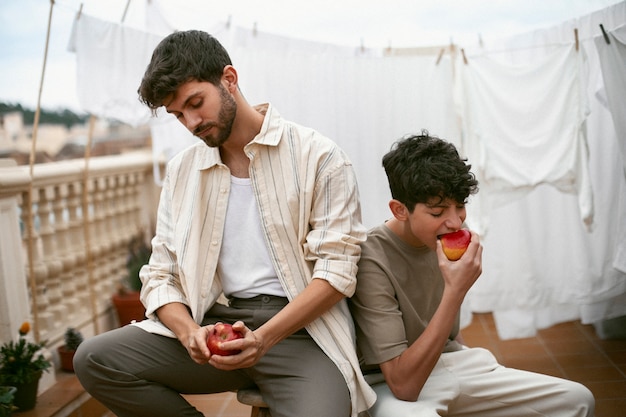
[[136, 105, 375, 416]]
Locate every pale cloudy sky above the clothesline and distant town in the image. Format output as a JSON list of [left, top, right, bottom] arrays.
[[0, 0, 620, 112]]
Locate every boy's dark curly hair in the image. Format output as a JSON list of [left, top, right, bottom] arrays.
[[383, 130, 478, 212]]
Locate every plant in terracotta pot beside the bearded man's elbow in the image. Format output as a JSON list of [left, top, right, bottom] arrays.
[[112, 234, 151, 326]]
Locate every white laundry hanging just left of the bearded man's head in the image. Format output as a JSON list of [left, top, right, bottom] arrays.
[[68, 13, 162, 126]]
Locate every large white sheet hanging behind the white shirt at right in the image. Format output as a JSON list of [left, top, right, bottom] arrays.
[[466, 2, 626, 339]]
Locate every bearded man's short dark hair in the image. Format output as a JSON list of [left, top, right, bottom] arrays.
[[138, 30, 232, 111]]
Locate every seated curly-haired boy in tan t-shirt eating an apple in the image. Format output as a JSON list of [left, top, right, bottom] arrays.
[[350, 132, 594, 417]]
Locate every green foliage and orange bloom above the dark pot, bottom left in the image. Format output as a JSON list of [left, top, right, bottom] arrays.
[[0, 321, 52, 386]]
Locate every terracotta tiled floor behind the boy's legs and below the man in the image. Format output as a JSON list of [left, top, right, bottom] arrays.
[[100, 314, 626, 417]]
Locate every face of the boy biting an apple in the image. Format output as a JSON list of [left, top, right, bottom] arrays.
[[405, 198, 467, 250]]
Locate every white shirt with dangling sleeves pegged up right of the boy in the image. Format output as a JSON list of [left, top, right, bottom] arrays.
[[456, 46, 593, 233]]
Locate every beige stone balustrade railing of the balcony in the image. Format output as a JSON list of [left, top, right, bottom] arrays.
[[0, 151, 160, 391]]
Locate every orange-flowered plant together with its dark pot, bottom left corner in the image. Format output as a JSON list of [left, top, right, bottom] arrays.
[[0, 321, 52, 411]]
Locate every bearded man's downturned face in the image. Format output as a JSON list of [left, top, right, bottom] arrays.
[[165, 80, 237, 147]]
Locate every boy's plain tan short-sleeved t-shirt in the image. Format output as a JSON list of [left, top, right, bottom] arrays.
[[350, 224, 460, 365]]
